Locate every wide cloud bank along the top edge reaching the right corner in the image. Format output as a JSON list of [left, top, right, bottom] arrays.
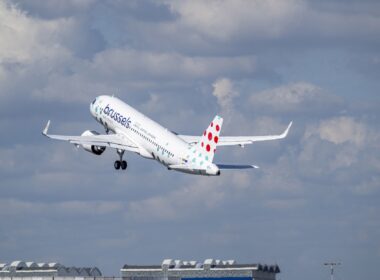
[[165, 0, 379, 53]]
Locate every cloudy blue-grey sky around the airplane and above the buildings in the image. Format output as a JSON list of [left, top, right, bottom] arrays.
[[0, 0, 380, 280]]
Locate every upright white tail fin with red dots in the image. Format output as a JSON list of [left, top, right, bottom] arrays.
[[196, 116, 223, 162]]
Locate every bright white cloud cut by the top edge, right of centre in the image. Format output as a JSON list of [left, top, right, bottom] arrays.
[[165, 0, 304, 41]]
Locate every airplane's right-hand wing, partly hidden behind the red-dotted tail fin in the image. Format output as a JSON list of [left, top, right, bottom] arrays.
[[177, 122, 293, 146]]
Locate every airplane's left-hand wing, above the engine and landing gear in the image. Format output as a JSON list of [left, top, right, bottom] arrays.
[[42, 121, 139, 152]]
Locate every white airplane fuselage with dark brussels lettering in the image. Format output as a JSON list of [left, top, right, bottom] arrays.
[[90, 95, 220, 175]]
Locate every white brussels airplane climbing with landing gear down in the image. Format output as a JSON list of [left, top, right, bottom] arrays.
[[42, 95, 292, 176]]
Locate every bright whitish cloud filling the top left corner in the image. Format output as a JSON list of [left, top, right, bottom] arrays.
[[0, 1, 103, 107]]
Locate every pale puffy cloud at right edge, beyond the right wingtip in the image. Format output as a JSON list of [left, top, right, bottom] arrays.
[[296, 117, 380, 193]]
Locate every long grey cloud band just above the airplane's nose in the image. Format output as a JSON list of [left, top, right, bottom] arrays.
[[33, 49, 257, 102]]
